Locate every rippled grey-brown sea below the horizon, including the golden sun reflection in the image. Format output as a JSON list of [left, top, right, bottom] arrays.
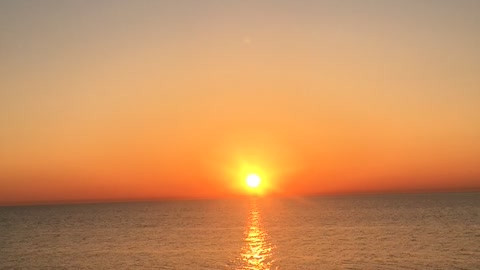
[[0, 193, 480, 269]]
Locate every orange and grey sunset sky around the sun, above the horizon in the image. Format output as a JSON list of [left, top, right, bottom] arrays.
[[0, 0, 480, 204]]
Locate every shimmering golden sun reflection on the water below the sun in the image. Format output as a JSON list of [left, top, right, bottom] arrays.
[[240, 201, 276, 270]]
